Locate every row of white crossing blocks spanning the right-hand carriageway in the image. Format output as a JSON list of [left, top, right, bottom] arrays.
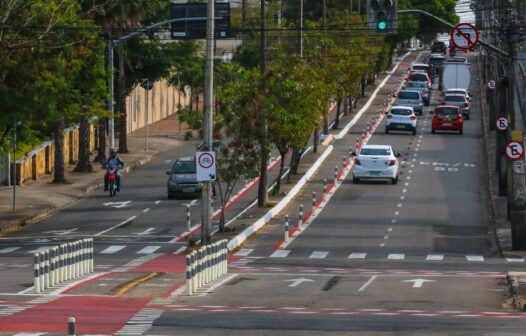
[[234, 248, 525, 265]]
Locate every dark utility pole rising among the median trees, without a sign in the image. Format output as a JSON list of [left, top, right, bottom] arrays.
[[258, 0, 268, 208]]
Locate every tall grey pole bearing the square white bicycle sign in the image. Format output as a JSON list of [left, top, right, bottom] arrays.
[[201, 0, 215, 245]]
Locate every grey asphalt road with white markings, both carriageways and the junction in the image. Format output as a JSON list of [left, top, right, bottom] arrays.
[[0, 53, 526, 336]]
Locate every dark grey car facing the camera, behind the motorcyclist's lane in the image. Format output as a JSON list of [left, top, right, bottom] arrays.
[[166, 157, 202, 199]]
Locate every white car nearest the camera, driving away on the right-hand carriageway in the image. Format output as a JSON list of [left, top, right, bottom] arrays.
[[353, 145, 400, 184]]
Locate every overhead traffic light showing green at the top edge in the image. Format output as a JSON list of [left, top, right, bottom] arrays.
[[367, 0, 397, 34]]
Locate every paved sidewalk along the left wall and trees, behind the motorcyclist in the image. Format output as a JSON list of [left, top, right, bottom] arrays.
[[0, 114, 195, 234]]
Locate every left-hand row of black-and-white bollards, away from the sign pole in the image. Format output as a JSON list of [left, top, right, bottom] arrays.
[[33, 238, 93, 293]]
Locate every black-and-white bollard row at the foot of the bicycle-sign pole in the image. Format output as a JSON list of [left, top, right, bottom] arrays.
[[186, 239, 228, 295]]
